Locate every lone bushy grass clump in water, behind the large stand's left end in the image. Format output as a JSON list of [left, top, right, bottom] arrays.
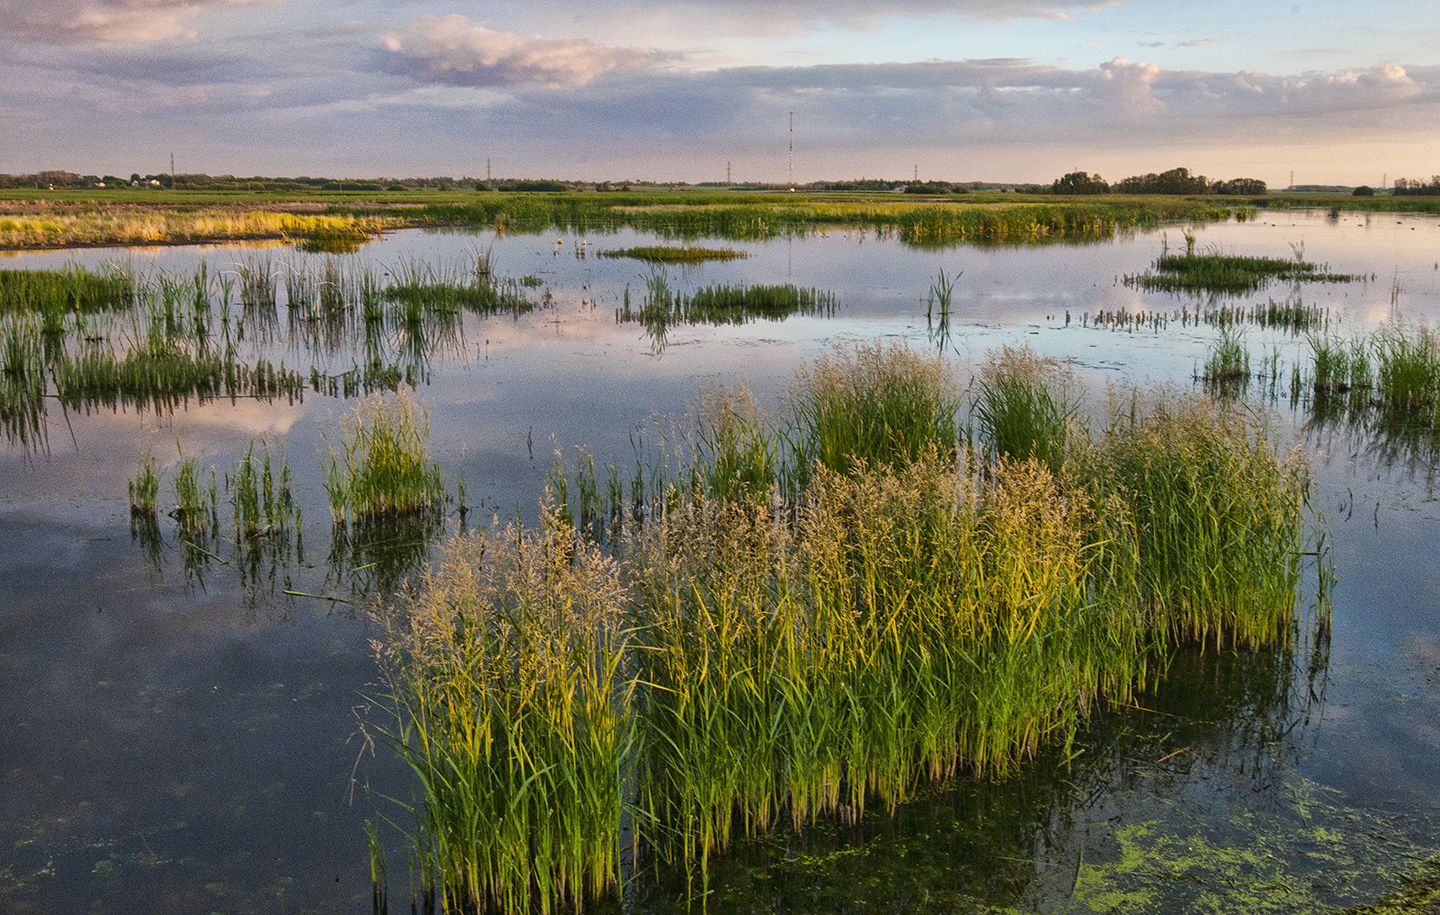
[[321, 390, 445, 523]]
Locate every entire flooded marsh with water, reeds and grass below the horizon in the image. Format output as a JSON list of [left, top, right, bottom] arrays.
[[0, 193, 1440, 915]]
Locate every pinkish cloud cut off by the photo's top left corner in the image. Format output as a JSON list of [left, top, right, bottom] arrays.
[[0, 0, 274, 45]]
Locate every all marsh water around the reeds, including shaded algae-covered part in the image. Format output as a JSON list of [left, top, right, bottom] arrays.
[[0, 210, 1440, 914]]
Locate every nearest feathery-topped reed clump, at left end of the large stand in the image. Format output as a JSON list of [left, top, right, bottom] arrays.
[[377, 516, 635, 912]]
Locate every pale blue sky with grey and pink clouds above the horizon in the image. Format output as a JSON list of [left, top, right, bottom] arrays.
[[0, 0, 1440, 187]]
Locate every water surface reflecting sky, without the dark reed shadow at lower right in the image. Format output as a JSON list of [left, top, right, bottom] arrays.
[[0, 212, 1440, 912]]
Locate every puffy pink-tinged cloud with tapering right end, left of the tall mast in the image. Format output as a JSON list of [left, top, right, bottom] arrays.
[[383, 14, 677, 86]]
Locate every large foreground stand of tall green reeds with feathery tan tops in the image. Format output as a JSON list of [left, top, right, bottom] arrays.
[[373, 346, 1309, 911]]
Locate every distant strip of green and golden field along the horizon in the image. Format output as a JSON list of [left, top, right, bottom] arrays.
[[0, 187, 1440, 249]]
